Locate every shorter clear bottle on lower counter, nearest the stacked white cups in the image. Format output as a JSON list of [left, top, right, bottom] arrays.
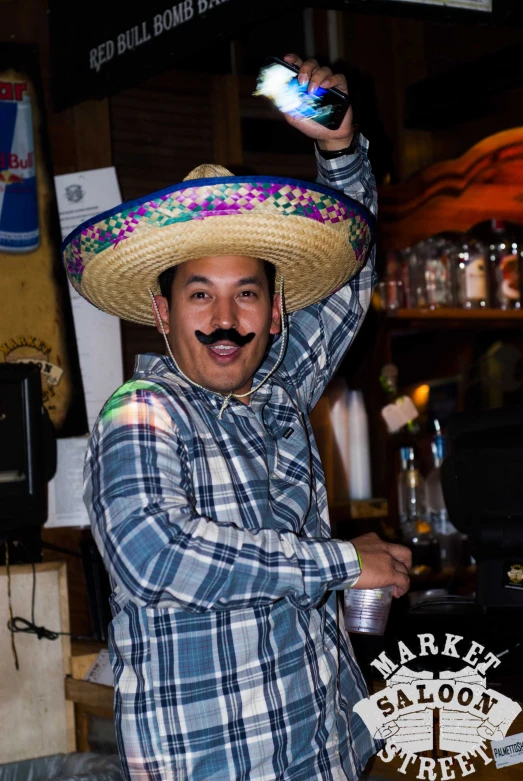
[[398, 447, 440, 575]]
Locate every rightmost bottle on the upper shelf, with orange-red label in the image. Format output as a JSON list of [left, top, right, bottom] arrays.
[[489, 220, 521, 309]]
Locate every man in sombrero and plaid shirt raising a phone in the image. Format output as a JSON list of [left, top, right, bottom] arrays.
[[64, 55, 410, 781]]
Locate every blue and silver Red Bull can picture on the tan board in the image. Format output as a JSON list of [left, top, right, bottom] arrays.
[[0, 81, 40, 252]]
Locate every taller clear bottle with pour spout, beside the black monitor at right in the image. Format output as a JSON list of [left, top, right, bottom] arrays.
[[425, 420, 464, 569]]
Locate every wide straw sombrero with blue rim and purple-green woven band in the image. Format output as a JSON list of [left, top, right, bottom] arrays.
[[62, 165, 374, 325]]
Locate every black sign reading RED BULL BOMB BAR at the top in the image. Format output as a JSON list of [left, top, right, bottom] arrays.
[[49, 0, 284, 110]]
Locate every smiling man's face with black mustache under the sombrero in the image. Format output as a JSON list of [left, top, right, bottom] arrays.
[[152, 255, 280, 403]]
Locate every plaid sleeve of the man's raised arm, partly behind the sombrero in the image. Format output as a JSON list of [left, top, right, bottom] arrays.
[[273, 136, 377, 412]]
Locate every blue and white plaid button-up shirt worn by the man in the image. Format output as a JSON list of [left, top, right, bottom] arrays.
[[84, 139, 381, 781]]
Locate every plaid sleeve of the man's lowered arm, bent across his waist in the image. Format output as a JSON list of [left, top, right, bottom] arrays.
[[84, 389, 361, 613]]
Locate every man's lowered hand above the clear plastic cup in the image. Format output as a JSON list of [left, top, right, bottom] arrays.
[[351, 532, 412, 597]]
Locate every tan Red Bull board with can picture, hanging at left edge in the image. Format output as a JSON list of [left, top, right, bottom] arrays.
[[0, 43, 87, 436]]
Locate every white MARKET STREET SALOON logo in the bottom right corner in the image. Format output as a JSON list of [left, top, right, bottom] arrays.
[[354, 633, 521, 781]]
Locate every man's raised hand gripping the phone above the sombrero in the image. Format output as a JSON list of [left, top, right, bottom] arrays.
[[283, 54, 354, 151]]
